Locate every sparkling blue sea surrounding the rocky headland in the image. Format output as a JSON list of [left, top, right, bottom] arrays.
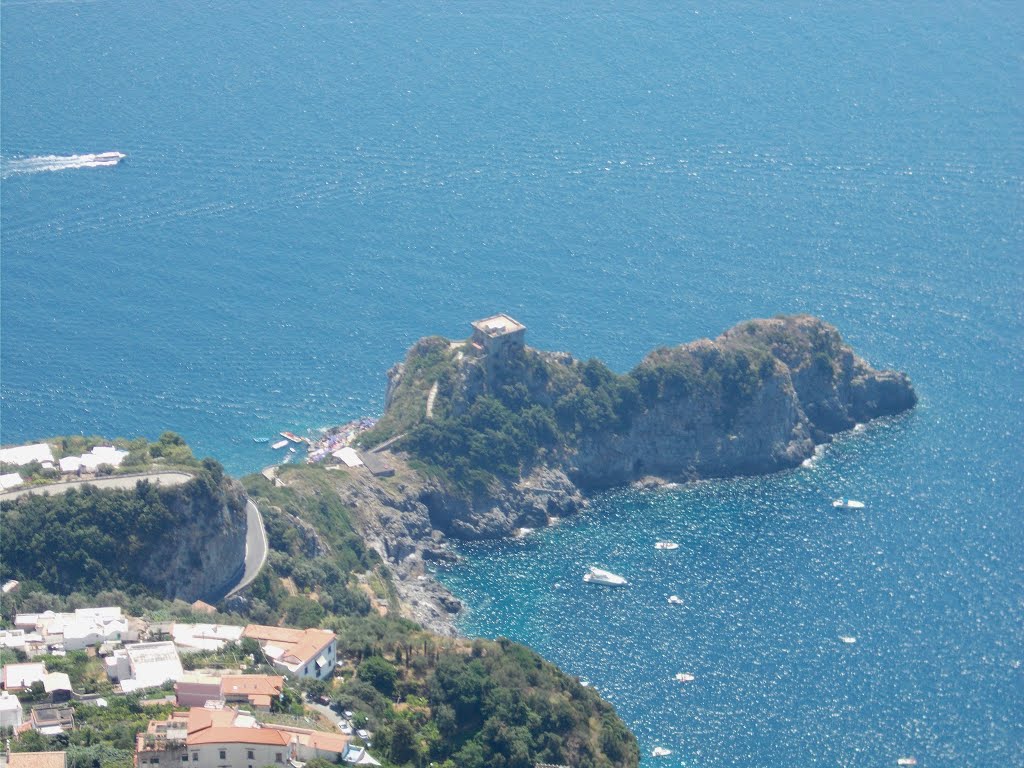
[[0, 0, 1024, 768]]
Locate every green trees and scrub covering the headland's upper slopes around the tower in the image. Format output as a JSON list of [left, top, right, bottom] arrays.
[[365, 329, 774, 490]]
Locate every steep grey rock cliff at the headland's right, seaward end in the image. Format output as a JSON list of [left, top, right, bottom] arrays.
[[568, 316, 916, 487]]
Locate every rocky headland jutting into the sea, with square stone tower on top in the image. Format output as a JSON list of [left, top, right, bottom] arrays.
[[272, 315, 916, 634]]
